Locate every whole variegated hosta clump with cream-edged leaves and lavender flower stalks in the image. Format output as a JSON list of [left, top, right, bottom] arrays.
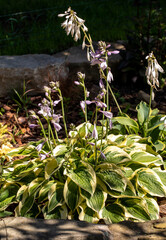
[[0, 8, 166, 223]]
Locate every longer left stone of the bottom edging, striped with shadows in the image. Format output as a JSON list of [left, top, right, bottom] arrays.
[[0, 217, 113, 240]]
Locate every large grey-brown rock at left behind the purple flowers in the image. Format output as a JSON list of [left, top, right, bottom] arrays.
[[0, 54, 68, 97]]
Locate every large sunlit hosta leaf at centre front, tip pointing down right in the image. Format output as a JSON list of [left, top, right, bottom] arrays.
[[64, 161, 96, 195]]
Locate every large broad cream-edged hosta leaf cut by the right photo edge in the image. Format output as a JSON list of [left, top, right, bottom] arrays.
[[136, 168, 166, 197]]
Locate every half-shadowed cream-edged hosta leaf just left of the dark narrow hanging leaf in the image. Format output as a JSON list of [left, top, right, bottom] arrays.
[[48, 182, 64, 213]]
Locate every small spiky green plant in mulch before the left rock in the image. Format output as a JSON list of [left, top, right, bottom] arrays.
[[13, 80, 33, 117]]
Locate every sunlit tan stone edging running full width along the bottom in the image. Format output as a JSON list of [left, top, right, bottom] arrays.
[[0, 217, 166, 240]]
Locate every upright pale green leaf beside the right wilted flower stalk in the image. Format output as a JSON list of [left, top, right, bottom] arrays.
[[136, 101, 149, 125]]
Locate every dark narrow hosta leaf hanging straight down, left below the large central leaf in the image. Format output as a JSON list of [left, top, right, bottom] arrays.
[[63, 177, 80, 211]]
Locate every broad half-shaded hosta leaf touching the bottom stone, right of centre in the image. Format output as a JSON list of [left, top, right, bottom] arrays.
[[99, 203, 125, 224]]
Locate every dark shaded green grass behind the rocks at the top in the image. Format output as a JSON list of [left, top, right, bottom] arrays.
[[0, 0, 166, 55]]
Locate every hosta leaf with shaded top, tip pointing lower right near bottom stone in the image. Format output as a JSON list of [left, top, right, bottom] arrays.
[[120, 198, 151, 221]]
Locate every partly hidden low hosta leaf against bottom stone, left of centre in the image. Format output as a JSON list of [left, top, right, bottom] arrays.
[[43, 204, 68, 219]]
